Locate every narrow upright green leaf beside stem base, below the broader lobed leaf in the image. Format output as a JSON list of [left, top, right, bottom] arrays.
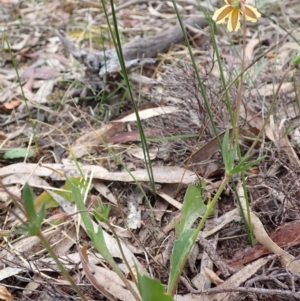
[[168, 229, 196, 296]]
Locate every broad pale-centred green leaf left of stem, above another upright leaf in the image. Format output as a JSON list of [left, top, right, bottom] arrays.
[[175, 184, 206, 237]]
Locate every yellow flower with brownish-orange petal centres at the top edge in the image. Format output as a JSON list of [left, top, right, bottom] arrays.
[[213, 0, 261, 31]]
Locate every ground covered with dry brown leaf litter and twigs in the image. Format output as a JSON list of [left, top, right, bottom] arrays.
[[0, 0, 300, 300]]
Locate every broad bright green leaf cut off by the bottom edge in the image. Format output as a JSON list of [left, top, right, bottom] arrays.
[[137, 271, 173, 301]]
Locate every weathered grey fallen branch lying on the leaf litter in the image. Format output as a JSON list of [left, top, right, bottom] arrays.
[[56, 17, 207, 79]]
